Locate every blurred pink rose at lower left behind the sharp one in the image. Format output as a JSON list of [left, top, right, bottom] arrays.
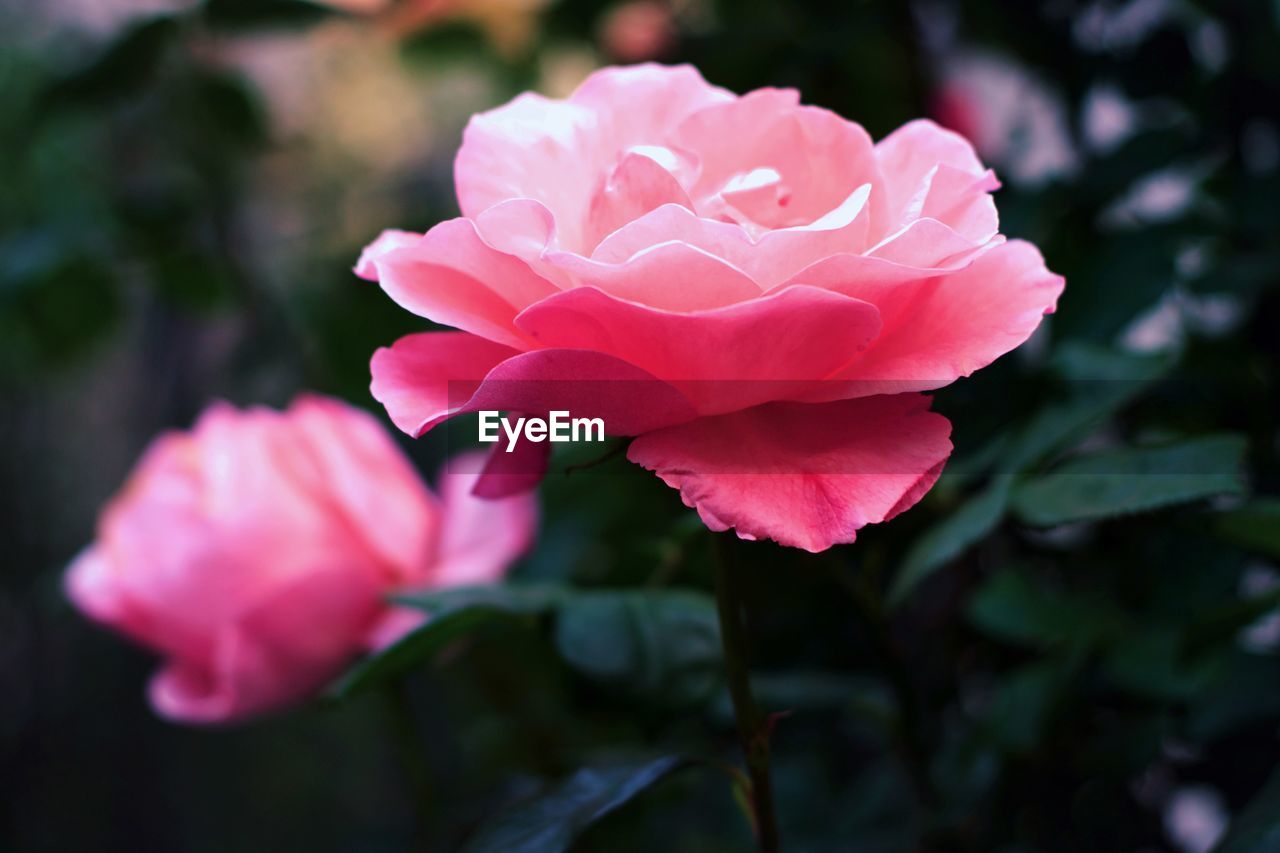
[[67, 397, 536, 724]]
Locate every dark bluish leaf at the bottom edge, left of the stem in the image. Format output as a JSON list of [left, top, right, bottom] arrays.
[[463, 757, 689, 853]]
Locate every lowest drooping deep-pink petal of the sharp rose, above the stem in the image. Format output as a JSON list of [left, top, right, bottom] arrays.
[[627, 394, 951, 552]]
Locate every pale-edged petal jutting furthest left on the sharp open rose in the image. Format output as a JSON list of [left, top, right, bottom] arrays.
[[362, 219, 557, 348]]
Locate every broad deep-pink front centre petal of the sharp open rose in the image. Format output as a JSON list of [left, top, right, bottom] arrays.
[[517, 287, 881, 412]]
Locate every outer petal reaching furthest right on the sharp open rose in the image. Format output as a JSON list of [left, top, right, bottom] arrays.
[[838, 240, 1064, 393]]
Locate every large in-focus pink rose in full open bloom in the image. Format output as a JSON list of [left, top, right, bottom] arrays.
[[356, 64, 1062, 551]]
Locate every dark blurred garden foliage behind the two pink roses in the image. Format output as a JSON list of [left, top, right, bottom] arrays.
[[0, 0, 1280, 853]]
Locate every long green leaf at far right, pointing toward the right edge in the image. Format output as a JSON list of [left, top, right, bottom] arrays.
[[1012, 434, 1247, 526]]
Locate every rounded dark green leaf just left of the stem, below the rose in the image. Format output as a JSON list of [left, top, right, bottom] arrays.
[[556, 589, 721, 706]]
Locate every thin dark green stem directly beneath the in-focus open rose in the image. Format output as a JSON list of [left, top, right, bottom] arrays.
[[712, 535, 780, 853]]
